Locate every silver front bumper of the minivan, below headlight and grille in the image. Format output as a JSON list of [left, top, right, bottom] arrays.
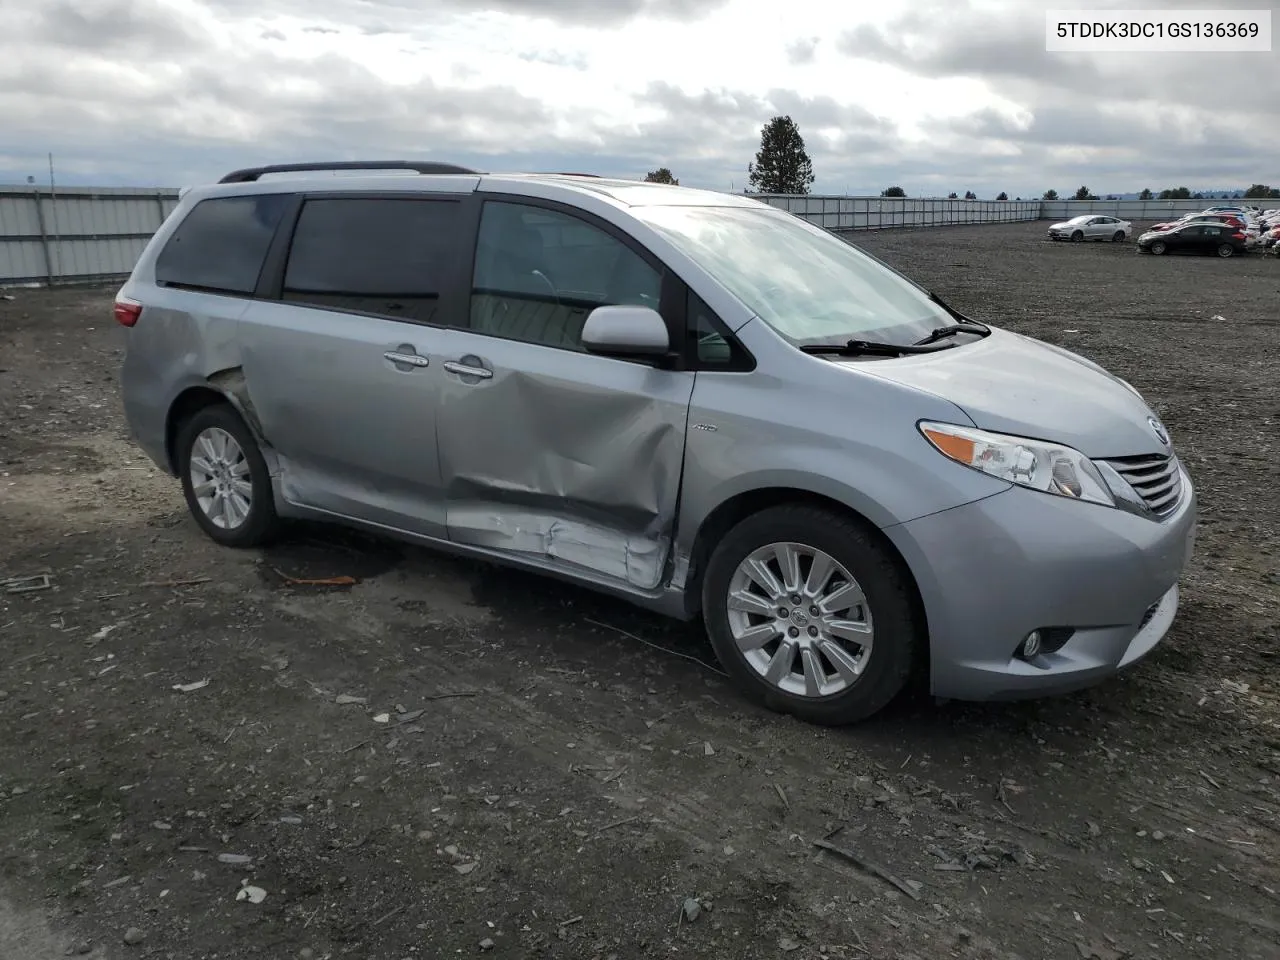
[[884, 471, 1197, 700]]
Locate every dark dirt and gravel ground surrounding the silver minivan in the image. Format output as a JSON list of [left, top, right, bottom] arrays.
[[0, 223, 1280, 960]]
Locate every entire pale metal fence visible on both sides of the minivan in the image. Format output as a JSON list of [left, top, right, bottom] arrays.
[[0, 186, 1259, 285]]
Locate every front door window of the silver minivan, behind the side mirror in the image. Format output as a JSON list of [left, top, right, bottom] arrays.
[[471, 202, 662, 349]]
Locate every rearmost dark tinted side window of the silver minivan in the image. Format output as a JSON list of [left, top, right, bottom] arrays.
[[156, 193, 291, 294]]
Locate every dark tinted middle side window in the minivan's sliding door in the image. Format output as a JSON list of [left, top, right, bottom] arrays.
[[283, 197, 458, 323]]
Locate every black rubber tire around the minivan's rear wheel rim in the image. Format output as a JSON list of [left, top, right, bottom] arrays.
[[174, 403, 280, 548]]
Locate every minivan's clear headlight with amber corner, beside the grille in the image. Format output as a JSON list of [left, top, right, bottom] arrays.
[[920, 422, 1111, 507]]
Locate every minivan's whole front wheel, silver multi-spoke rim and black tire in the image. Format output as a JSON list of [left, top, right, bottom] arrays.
[[703, 504, 923, 726]]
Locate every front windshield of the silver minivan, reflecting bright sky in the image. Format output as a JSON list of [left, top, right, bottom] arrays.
[[631, 206, 954, 344]]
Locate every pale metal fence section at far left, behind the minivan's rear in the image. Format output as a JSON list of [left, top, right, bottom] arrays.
[[0, 187, 178, 284]]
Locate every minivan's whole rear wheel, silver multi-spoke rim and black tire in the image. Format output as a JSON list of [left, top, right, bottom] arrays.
[[175, 403, 279, 547]]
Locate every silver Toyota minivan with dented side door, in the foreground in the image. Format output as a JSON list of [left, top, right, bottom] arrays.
[[115, 161, 1196, 723]]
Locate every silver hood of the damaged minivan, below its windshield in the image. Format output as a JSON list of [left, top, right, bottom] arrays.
[[839, 328, 1170, 458]]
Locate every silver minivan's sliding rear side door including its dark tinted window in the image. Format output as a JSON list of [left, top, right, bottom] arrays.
[[239, 196, 466, 539]]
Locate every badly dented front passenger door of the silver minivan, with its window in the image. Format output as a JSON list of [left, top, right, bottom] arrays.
[[439, 200, 694, 590]]
